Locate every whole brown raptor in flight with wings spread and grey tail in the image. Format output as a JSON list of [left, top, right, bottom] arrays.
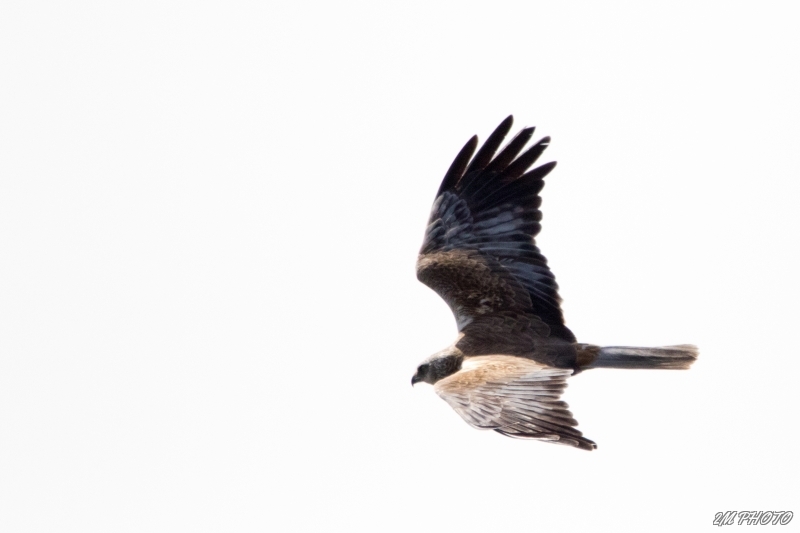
[[411, 116, 697, 450]]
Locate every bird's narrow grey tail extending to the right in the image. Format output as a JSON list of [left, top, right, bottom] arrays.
[[581, 344, 698, 370]]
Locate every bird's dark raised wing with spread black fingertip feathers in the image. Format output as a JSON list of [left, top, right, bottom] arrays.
[[417, 116, 575, 342]]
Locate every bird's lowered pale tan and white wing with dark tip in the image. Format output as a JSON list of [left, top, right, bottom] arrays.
[[434, 355, 597, 450]]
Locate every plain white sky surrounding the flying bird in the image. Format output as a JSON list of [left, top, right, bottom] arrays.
[[0, 1, 800, 533]]
